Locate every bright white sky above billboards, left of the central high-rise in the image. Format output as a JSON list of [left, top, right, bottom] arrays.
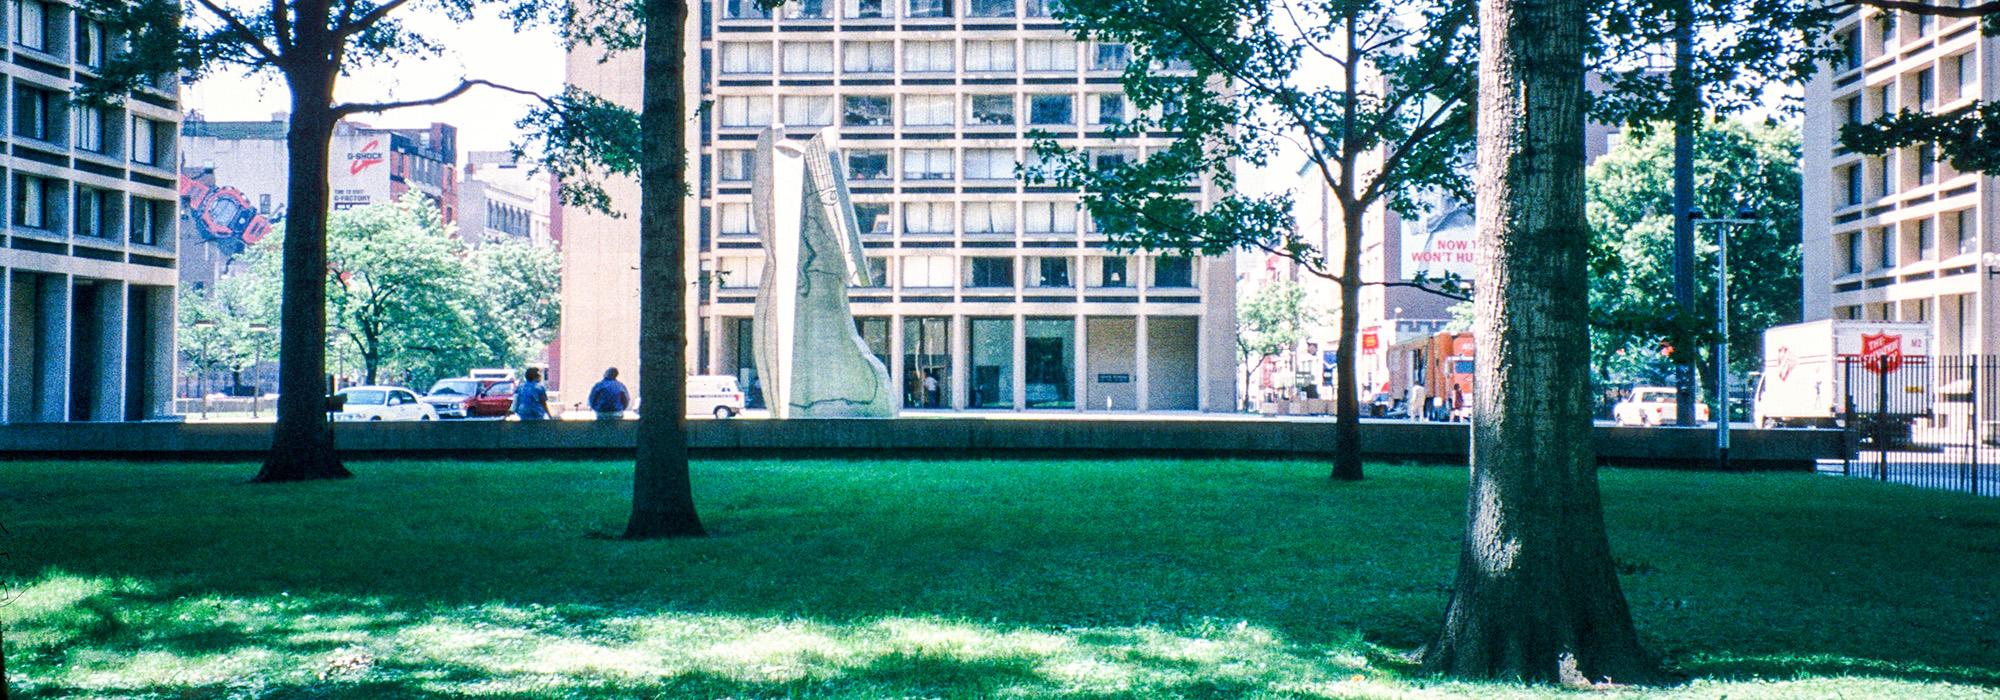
[[182, 14, 562, 158]]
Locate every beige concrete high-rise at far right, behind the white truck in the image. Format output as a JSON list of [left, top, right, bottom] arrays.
[[1800, 8, 2000, 354]]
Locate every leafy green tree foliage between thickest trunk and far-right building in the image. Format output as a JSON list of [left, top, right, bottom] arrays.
[[1588, 120, 1802, 382]]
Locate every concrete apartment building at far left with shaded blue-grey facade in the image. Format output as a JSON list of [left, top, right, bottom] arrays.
[[0, 0, 180, 422]]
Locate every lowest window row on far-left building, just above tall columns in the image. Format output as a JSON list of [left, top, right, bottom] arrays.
[[12, 172, 174, 246]]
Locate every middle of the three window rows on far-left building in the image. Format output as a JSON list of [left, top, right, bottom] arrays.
[[12, 80, 174, 166]]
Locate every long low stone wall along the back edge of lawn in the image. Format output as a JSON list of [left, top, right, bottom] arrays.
[[0, 418, 1844, 470]]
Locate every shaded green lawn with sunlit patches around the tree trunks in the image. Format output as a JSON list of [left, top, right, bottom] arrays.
[[0, 460, 2000, 698]]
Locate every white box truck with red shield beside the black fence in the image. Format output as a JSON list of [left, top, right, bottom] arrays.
[[1756, 320, 1932, 438]]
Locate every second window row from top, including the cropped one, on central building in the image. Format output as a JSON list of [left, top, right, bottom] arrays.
[[716, 38, 1132, 76]]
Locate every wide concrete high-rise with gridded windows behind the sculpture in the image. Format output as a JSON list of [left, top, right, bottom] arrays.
[[560, 0, 1236, 410]]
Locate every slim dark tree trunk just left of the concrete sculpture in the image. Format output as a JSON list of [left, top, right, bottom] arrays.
[[624, 0, 706, 540]]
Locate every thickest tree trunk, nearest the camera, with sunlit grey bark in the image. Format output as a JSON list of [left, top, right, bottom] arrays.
[[1424, 0, 1660, 684]]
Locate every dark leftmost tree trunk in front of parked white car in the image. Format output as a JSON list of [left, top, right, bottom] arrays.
[[254, 64, 354, 482]]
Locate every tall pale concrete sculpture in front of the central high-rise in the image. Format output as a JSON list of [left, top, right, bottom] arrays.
[[750, 128, 896, 418]]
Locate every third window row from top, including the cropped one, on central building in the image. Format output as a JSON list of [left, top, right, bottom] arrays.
[[716, 92, 1134, 128]]
